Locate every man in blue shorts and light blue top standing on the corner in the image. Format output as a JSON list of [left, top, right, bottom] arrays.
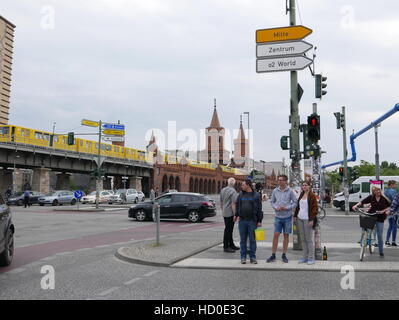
[[266, 174, 297, 263]]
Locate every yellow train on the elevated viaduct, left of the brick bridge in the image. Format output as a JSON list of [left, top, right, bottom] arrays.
[[0, 125, 154, 164]]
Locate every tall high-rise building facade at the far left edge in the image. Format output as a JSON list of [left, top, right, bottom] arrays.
[[0, 16, 15, 125]]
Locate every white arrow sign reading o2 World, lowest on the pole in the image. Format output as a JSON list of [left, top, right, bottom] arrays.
[[256, 56, 313, 73]]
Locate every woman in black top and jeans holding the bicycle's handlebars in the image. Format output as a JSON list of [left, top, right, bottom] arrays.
[[352, 187, 390, 257]]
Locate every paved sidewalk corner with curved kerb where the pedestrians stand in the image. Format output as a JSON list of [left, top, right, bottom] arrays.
[[116, 217, 399, 272]]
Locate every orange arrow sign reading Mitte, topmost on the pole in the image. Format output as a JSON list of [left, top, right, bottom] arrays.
[[256, 26, 313, 43]]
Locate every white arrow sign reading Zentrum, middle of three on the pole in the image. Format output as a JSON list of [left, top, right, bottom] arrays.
[[256, 41, 313, 58]]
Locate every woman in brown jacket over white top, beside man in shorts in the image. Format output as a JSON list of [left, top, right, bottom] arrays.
[[294, 181, 318, 265]]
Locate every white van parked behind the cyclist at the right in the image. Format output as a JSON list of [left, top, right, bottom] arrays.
[[333, 176, 399, 211]]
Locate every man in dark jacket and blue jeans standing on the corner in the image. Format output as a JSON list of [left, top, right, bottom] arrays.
[[234, 179, 263, 264]]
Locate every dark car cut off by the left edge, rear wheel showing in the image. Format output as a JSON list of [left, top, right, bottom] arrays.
[[0, 195, 15, 267]]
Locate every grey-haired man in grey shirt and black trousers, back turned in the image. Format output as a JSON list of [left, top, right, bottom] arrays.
[[220, 178, 240, 252]]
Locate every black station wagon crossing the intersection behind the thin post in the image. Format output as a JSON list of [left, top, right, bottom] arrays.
[[129, 192, 216, 222]]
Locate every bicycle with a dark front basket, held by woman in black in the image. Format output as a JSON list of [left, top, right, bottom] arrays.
[[356, 208, 379, 261]]
